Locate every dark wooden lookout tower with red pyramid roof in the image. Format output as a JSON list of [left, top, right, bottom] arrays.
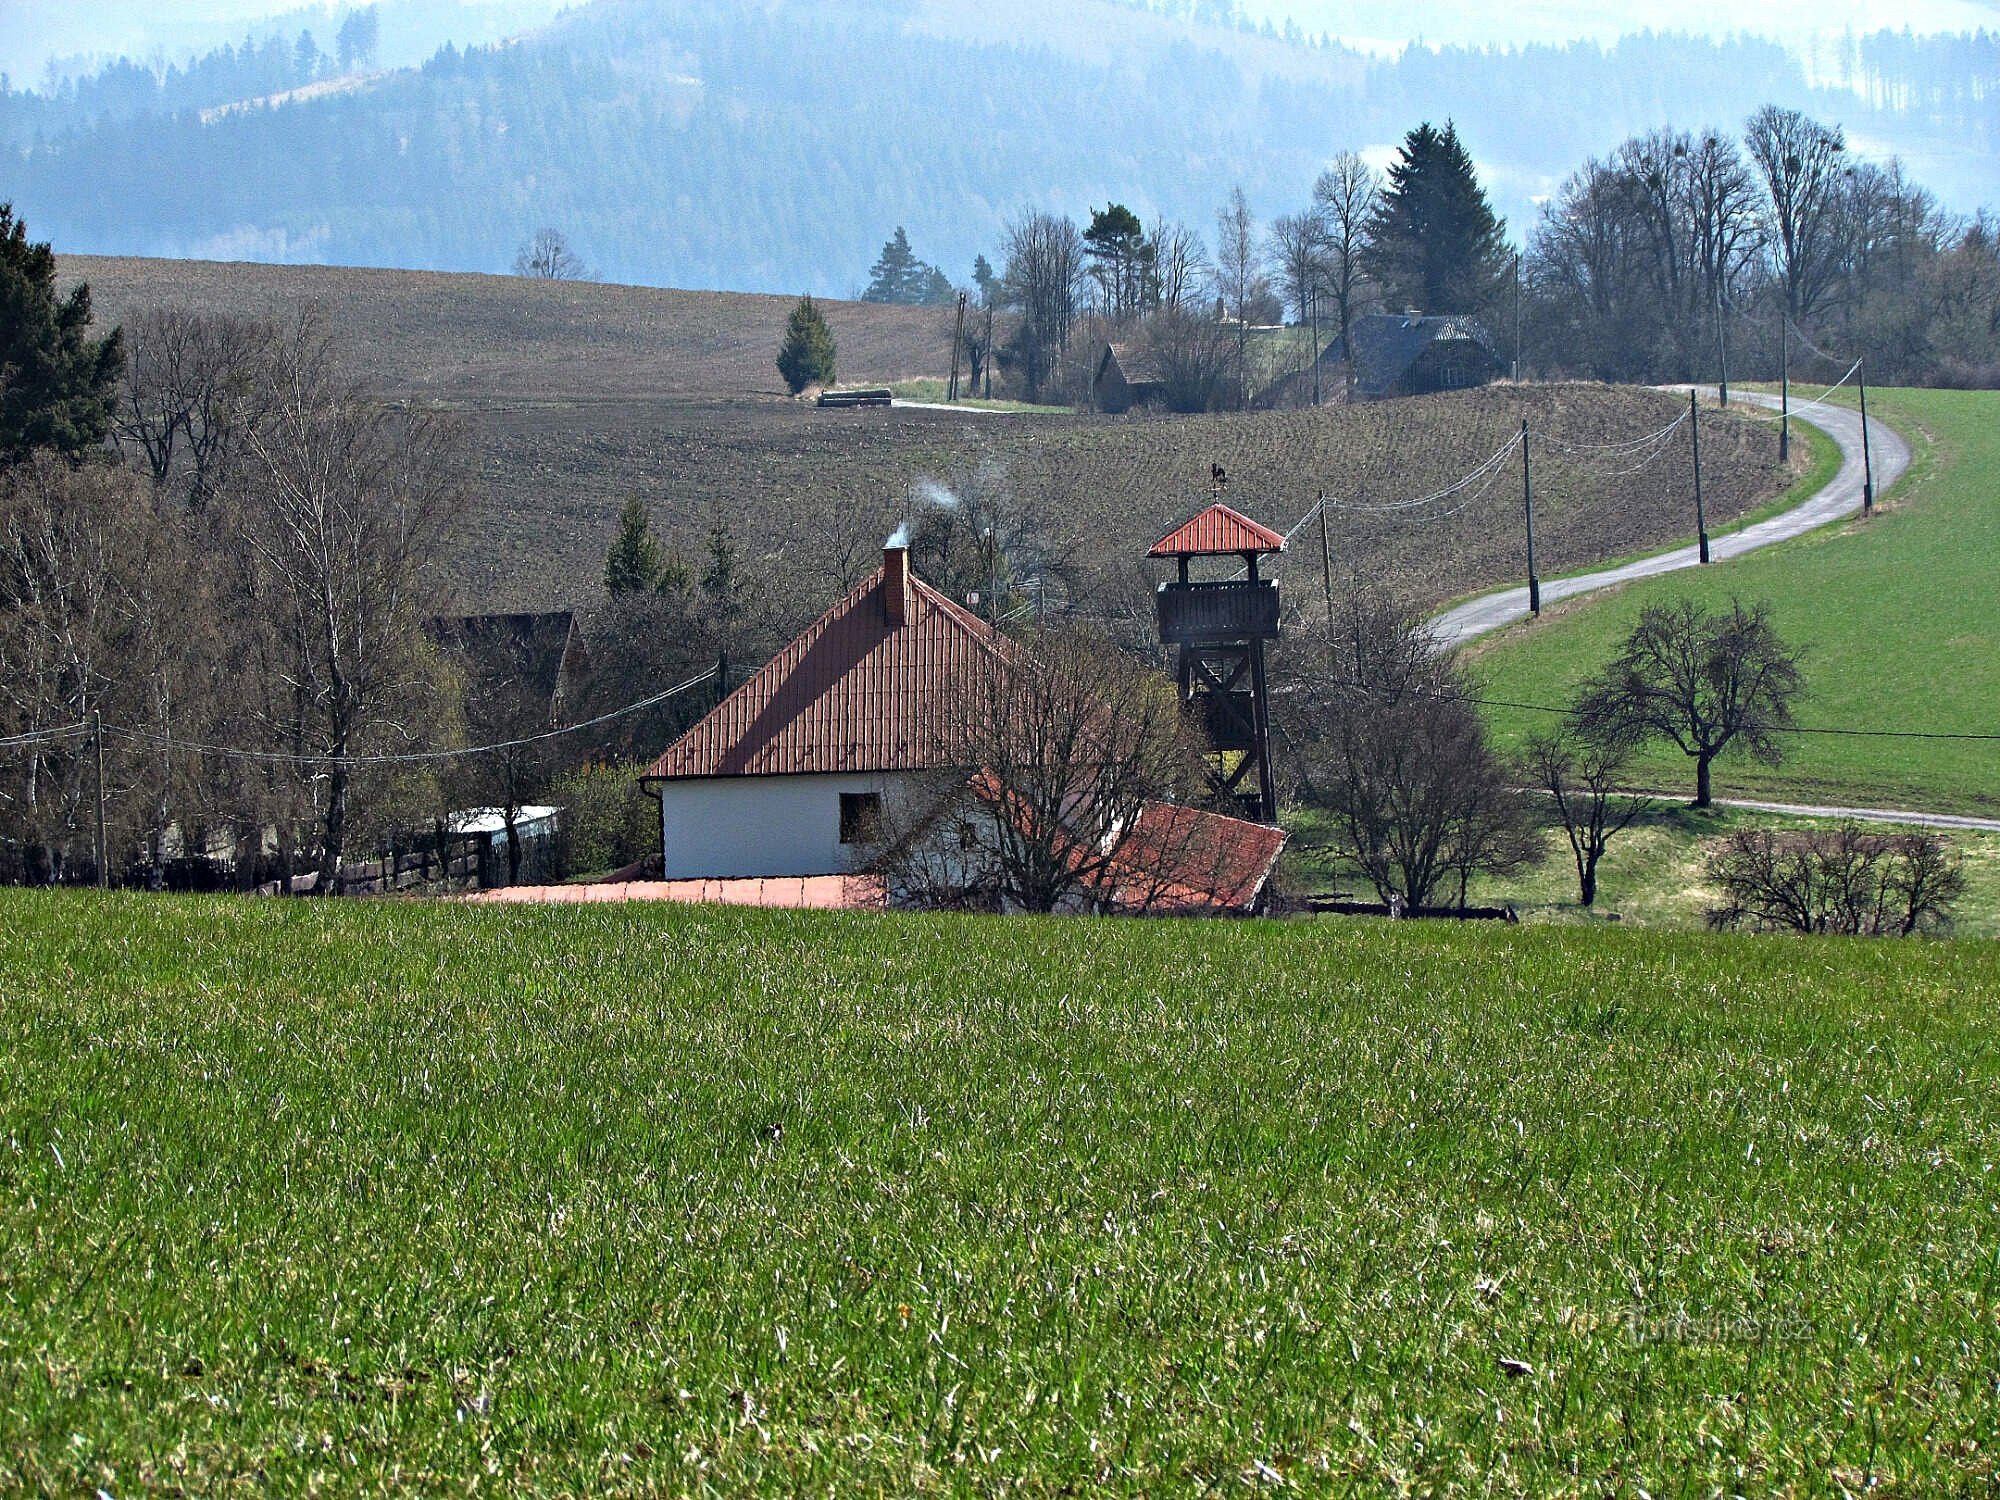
[[1146, 502, 1284, 822]]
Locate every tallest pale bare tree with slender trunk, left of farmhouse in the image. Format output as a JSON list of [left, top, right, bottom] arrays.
[[232, 312, 464, 890]]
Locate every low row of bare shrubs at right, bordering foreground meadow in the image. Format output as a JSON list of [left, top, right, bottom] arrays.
[[1708, 822, 1966, 938]]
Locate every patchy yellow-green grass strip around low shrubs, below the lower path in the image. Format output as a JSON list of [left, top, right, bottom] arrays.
[[1286, 800, 2000, 938]]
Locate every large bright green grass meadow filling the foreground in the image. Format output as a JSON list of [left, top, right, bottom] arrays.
[[0, 892, 2000, 1496]]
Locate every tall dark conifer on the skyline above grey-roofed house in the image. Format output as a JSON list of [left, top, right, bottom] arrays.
[[1366, 120, 1508, 312]]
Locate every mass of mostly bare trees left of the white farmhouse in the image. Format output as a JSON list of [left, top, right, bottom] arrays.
[[0, 206, 746, 890]]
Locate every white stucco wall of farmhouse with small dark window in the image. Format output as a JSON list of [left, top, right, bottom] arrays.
[[656, 772, 926, 880]]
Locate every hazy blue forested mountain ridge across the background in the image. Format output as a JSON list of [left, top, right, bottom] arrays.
[[0, 0, 2000, 294]]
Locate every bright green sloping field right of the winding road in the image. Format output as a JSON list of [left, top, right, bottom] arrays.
[[1472, 390, 2000, 814]]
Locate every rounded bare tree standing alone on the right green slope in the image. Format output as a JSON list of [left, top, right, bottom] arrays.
[[1578, 598, 1804, 808]]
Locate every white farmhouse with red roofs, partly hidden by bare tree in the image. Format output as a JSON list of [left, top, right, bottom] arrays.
[[642, 546, 1284, 914]]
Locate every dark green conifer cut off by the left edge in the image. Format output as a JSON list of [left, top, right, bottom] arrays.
[[0, 204, 124, 468]]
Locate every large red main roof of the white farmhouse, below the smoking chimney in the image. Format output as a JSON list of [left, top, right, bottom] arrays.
[[646, 570, 1006, 780]]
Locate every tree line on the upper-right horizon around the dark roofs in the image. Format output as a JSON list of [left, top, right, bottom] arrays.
[[872, 106, 2000, 412]]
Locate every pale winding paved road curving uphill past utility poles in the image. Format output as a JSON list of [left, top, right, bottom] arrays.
[[1430, 386, 1910, 648]]
